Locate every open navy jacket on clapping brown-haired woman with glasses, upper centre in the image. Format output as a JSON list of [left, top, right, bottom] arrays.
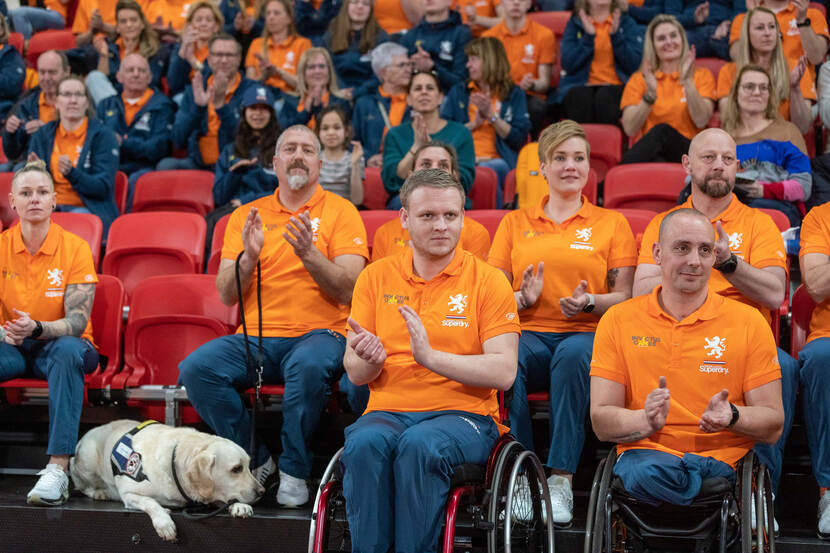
[[441, 83, 530, 168]]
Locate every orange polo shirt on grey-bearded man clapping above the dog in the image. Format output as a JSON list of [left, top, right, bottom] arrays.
[[222, 184, 369, 338]]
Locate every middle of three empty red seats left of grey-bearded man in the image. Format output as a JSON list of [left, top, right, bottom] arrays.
[[102, 211, 206, 296]]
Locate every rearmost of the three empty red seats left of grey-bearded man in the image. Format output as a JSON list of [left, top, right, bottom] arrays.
[[132, 170, 213, 216]]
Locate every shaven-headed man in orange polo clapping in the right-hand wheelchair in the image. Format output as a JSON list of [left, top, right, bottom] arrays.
[[590, 204, 785, 504]]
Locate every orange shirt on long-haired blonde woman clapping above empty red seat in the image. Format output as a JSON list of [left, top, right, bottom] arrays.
[[620, 67, 716, 140]]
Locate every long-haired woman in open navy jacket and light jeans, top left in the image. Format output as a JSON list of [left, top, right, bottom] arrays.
[[86, 0, 170, 106]]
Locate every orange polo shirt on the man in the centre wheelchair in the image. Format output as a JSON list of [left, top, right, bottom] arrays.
[[351, 248, 521, 433]]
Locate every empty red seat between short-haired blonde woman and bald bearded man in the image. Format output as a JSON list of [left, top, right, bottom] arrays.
[[603, 163, 686, 213]]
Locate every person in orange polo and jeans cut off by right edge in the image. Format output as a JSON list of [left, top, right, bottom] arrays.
[[798, 204, 830, 539]]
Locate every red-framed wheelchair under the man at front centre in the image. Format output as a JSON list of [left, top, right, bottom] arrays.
[[308, 434, 554, 553]]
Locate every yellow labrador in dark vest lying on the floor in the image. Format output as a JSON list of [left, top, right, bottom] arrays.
[[69, 420, 265, 541]]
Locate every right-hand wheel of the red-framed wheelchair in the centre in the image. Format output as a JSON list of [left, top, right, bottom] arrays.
[[488, 443, 554, 553]]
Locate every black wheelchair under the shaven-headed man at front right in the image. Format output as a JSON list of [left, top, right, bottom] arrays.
[[584, 448, 775, 553]]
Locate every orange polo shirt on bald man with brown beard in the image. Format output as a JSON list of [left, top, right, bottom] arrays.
[[637, 194, 787, 323]]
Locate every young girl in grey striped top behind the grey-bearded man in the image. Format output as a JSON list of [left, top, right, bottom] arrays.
[[315, 105, 364, 206]]
